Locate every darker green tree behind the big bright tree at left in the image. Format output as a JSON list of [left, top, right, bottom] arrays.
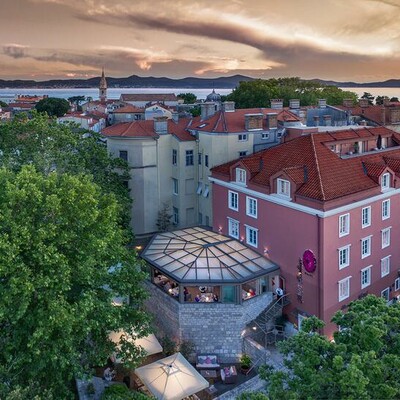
[[0, 112, 131, 231]]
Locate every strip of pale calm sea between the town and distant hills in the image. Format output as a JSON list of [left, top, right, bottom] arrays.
[[0, 87, 400, 103]]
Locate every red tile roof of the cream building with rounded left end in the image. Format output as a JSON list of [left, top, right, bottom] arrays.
[[102, 118, 196, 141]]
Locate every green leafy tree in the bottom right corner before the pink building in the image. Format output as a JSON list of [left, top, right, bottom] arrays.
[[262, 295, 400, 400]]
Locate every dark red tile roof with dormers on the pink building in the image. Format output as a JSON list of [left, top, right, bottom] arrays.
[[212, 127, 400, 201]]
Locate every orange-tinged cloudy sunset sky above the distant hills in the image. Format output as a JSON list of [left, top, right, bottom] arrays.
[[0, 0, 400, 82]]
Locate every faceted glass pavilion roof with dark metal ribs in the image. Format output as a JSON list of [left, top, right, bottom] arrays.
[[141, 227, 279, 283]]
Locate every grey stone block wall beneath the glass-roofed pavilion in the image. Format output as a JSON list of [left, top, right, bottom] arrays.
[[146, 282, 272, 362]]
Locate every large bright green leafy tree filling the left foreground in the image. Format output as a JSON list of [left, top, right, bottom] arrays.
[[0, 166, 148, 399]]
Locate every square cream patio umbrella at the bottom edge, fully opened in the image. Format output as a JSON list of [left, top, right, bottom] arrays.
[[135, 353, 209, 400]]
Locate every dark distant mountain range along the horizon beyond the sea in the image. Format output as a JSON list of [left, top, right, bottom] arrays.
[[0, 75, 400, 89]]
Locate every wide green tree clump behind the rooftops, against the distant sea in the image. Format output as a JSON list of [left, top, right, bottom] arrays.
[[227, 78, 357, 108]]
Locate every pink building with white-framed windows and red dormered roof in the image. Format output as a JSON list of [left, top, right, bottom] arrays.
[[210, 127, 400, 335]]
